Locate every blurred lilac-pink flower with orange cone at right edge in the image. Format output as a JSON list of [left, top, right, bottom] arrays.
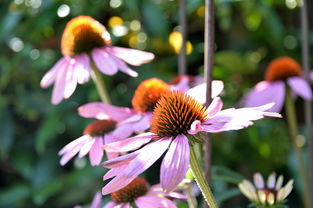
[[244, 57, 312, 112]]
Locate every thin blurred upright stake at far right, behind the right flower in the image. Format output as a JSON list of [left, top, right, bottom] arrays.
[[300, 0, 313, 207]]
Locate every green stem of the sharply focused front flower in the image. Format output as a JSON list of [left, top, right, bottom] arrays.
[[190, 145, 217, 208]]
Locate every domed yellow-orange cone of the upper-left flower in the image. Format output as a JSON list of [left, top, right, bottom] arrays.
[[61, 16, 111, 56]]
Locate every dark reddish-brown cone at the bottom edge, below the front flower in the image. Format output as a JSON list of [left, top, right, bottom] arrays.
[[111, 177, 149, 204]]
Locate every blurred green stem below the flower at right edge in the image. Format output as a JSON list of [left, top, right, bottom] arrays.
[[285, 88, 309, 208]]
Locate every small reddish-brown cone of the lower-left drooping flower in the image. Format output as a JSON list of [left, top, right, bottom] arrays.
[[84, 119, 116, 136]]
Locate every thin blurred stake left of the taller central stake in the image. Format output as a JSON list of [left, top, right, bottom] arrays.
[[178, 0, 187, 75]]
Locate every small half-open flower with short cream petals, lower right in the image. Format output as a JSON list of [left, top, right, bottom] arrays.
[[238, 173, 293, 207]]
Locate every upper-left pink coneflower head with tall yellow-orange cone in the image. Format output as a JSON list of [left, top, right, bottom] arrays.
[[40, 16, 154, 104]]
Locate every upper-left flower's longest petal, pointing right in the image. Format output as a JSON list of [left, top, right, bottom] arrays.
[[110, 47, 154, 66]]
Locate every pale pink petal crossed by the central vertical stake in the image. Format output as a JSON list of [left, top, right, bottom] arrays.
[[187, 80, 224, 104]]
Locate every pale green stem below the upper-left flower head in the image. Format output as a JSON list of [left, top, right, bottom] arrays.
[[91, 64, 111, 104]]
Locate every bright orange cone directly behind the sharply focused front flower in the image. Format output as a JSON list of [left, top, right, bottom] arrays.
[[132, 78, 170, 112]]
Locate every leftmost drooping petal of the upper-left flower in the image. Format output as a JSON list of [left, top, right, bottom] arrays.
[[40, 57, 67, 88]]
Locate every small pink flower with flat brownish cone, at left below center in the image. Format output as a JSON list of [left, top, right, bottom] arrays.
[[59, 119, 118, 166]]
